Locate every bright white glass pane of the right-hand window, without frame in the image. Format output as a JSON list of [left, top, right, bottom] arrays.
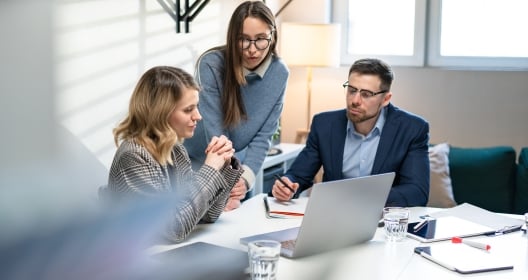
[[442, 0, 528, 57]]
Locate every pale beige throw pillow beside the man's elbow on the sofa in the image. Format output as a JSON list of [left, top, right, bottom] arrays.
[[427, 143, 456, 208]]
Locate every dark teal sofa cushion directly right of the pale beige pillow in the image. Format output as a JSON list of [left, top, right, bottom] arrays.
[[449, 146, 516, 213]]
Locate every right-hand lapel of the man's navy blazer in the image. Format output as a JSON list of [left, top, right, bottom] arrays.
[[372, 103, 400, 174]]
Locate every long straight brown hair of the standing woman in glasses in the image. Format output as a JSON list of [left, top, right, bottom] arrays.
[[200, 1, 277, 128]]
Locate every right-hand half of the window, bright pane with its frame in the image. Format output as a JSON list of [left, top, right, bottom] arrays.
[[428, 0, 528, 68]]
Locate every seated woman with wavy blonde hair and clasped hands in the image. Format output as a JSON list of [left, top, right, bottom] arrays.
[[108, 66, 243, 242]]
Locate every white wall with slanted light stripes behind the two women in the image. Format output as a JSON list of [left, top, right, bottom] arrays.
[[54, 0, 249, 167]]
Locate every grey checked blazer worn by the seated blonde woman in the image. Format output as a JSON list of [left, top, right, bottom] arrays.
[[108, 141, 243, 242]]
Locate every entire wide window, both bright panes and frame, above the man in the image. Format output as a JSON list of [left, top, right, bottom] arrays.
[[333, 0, 528, 68]]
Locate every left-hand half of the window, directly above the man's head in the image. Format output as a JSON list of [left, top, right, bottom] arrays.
[[334, 0, 426, 66]]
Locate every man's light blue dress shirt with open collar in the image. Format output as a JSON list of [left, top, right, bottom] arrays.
[[343, 107, 387, 178]]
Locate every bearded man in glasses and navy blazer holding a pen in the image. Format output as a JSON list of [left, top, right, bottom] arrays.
[[271, 59, 429, 207]]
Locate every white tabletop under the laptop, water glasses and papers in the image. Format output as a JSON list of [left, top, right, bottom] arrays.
[[149, 194, 528, 280]]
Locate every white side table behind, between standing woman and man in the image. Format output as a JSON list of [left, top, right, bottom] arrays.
[[253, 143, 304, 194]]
